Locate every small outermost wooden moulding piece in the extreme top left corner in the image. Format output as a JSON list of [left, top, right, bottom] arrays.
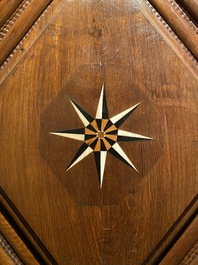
[[0, 0, 23, 27]]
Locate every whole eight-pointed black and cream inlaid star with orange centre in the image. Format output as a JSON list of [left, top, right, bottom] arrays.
[[50, 84, 153, 188]]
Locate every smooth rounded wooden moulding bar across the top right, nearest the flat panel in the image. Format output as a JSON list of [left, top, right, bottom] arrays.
[[149, 0, 198, 59]]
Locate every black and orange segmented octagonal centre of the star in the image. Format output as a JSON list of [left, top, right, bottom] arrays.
[[85, 119, 118, 152]]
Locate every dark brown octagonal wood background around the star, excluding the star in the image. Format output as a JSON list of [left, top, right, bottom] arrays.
[[40, 66, 163, 206]]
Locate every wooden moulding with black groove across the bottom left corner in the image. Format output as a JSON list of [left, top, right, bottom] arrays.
[[0, 188, 57, 265]]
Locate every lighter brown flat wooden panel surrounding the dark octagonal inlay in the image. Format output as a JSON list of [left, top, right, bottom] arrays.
[[0, 0, 198, 265]]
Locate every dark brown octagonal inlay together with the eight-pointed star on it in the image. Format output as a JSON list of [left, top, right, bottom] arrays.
[[40, 65, 163, 205]]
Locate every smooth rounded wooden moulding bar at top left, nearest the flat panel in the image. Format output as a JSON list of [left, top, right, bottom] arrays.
[[0, 0, 51, 65]]
